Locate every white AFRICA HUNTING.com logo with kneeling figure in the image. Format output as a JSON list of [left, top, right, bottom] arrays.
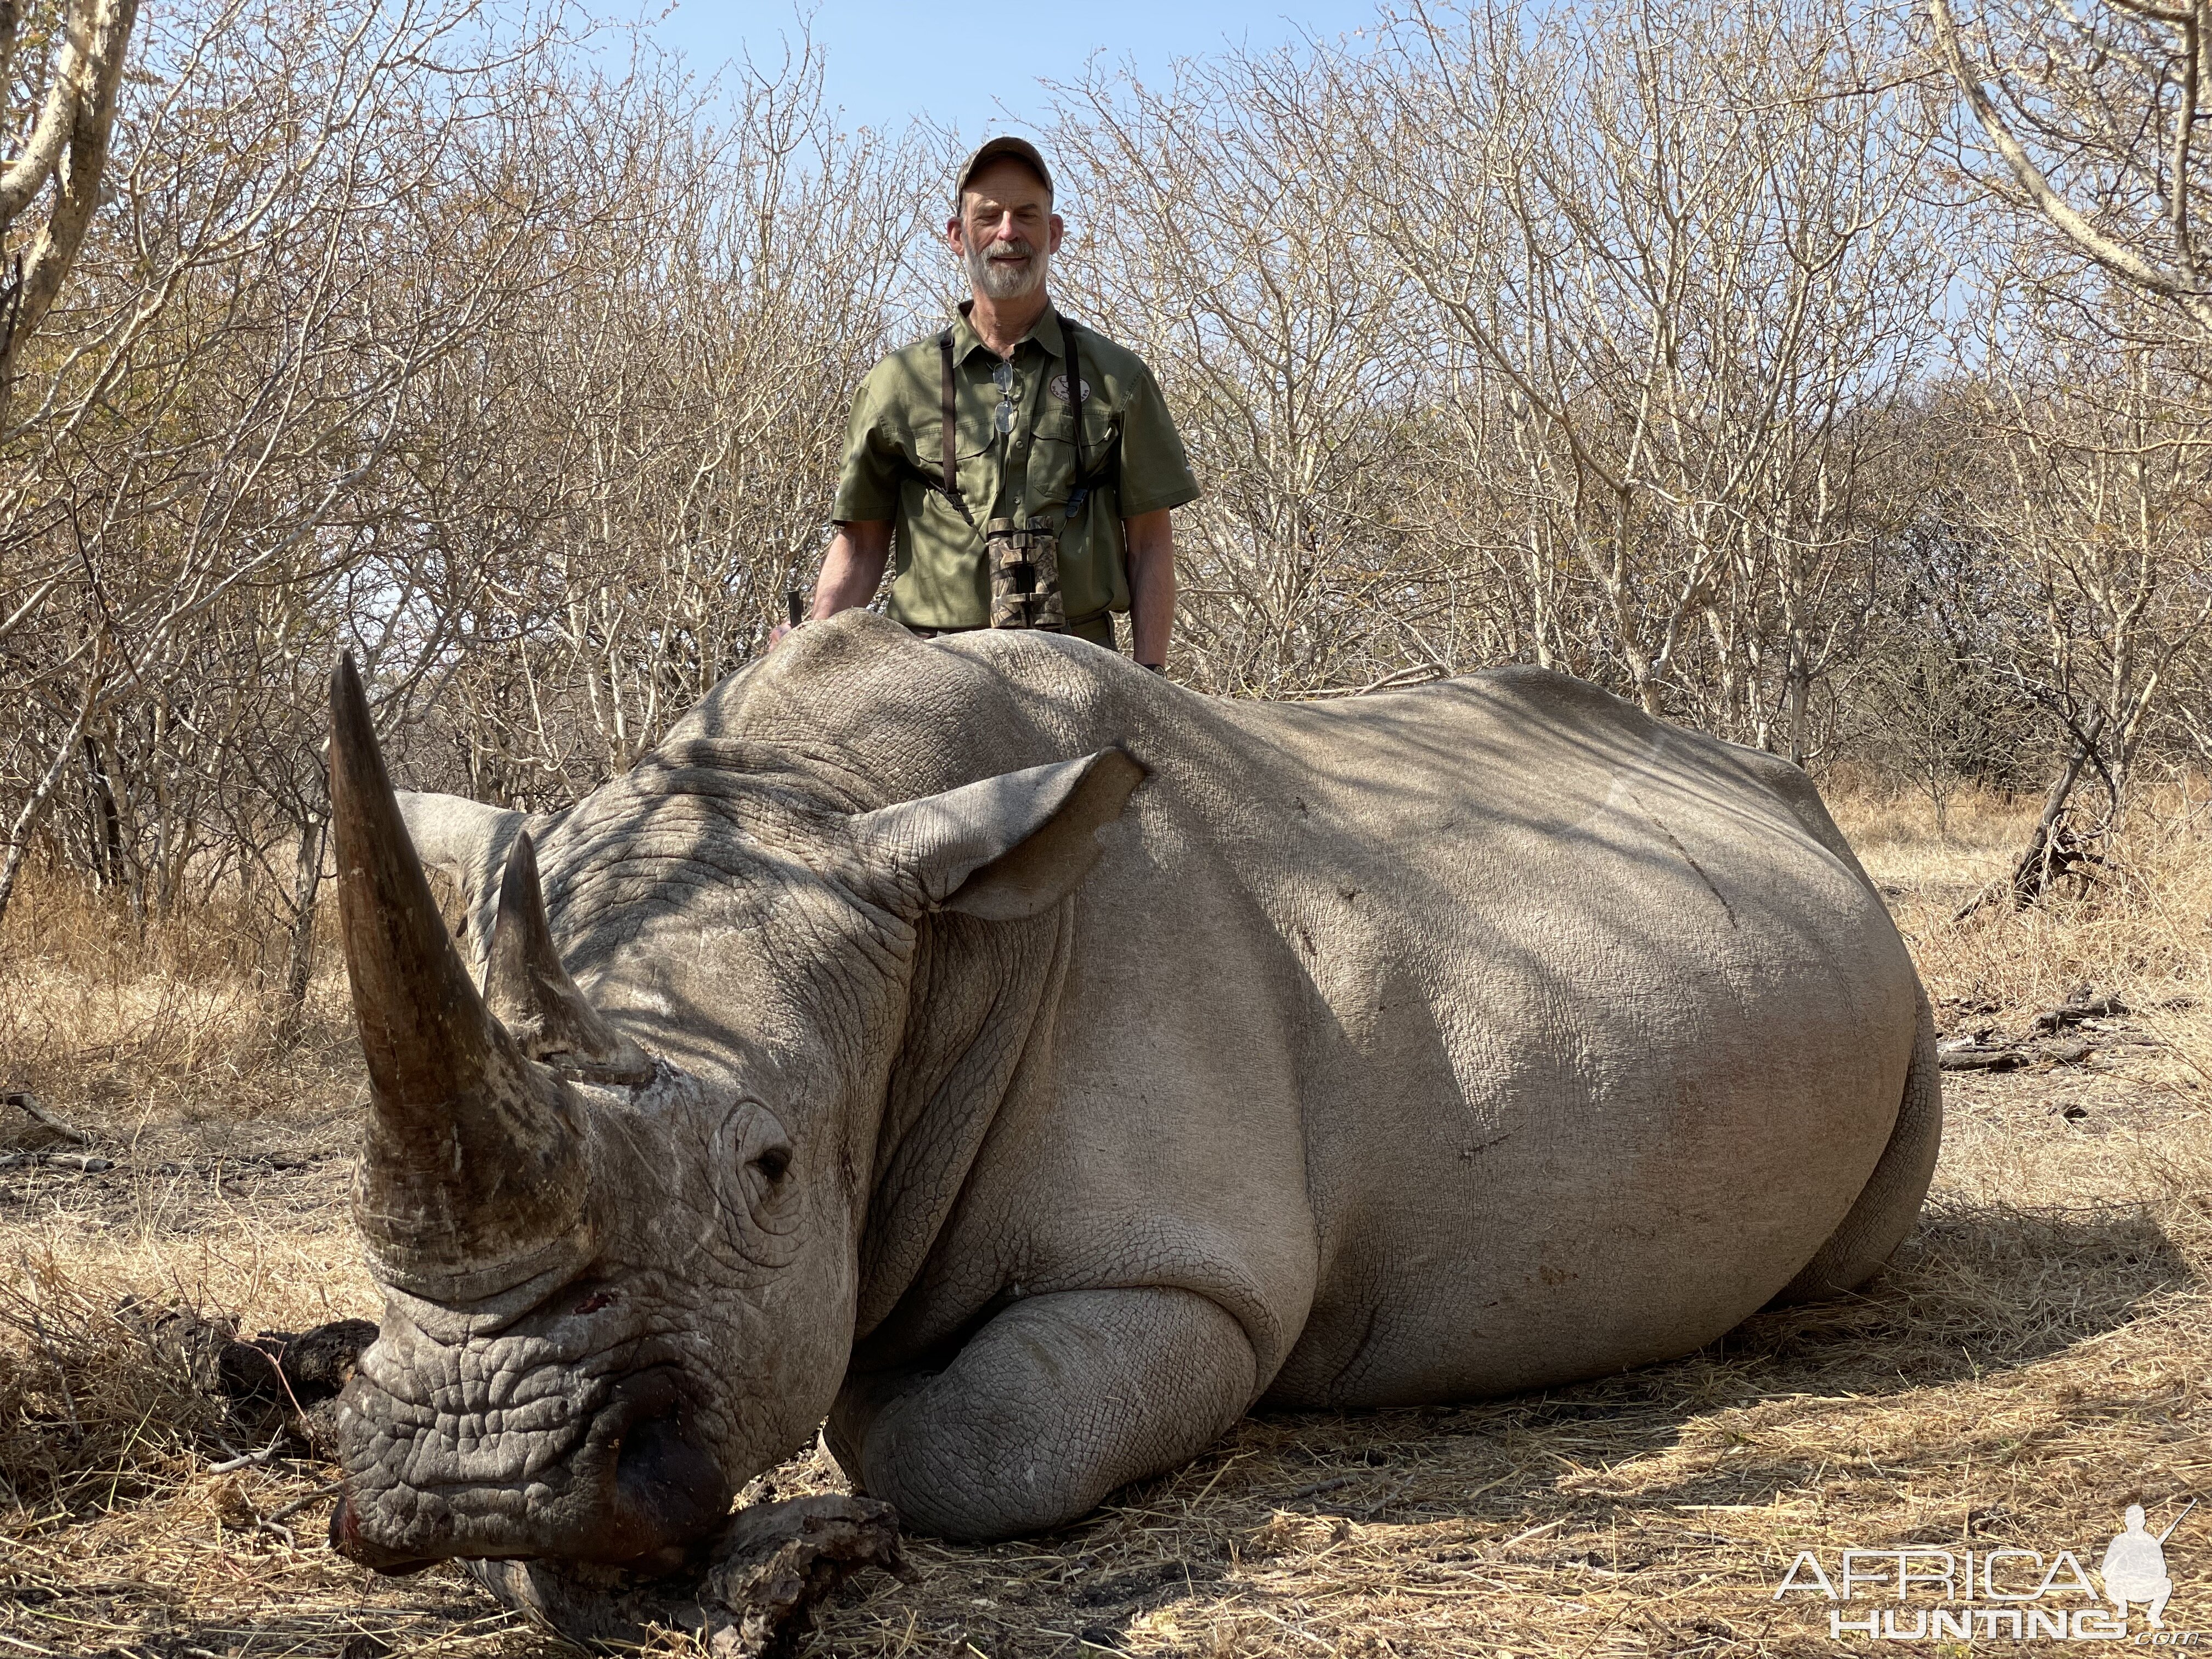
[[1774, 1498, 2212, 1650]]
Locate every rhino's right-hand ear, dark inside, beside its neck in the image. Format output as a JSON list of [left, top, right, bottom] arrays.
[[854, 750, 1146, 922]]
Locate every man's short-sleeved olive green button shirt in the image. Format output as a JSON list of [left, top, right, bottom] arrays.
[[830, 305, 1199, 628]]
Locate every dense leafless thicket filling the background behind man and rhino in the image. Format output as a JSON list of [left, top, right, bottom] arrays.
[[0, 0, 2212, 982]]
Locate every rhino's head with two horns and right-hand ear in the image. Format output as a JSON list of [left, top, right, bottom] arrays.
[[330, 659, 1144, 1573]]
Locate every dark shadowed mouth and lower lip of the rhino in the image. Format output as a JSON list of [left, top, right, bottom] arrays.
[[330, 1367, 735, 1575]]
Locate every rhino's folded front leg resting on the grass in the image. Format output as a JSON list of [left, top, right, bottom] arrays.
[[830, 1290, 1259, 1539]]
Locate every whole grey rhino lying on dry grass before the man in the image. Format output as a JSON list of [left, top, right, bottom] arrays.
[[330, 613, 1942, 1573]]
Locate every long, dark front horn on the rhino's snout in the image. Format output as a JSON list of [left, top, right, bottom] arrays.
[[330, 654, 589, 1301]]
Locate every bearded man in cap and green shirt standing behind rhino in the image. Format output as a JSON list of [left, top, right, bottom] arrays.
[[787, 137, 1199, 673]]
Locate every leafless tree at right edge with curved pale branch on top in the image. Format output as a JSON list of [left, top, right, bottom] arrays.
[[1931, 0, 2212, 905]]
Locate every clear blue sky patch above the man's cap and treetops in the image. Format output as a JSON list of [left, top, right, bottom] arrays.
[[652, 0, 1376, 139]]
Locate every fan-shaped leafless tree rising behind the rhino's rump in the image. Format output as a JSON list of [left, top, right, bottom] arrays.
[[1363, 0, 1944, 759]]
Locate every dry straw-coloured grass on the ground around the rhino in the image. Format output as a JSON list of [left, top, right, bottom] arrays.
[[0, 799, 2212, 1659]]
